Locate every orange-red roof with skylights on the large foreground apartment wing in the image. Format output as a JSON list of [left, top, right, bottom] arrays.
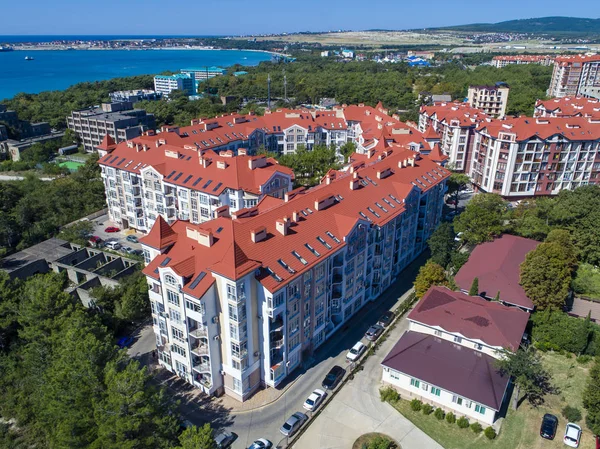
[[144, 150, 450, 294]]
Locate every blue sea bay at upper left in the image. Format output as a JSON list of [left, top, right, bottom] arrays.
[[0, 48, 271, 101]]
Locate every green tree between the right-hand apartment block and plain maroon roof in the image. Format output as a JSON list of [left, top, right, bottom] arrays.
[[454, 193, 506, 244]]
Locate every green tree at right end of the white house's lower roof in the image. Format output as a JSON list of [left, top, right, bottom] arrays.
[[496, 346, 554, 410]]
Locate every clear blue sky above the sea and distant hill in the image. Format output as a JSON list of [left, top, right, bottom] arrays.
[[0, 0, 600, 36]]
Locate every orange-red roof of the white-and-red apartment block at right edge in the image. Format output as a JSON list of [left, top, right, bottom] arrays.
[[478, 117, 600, 141]]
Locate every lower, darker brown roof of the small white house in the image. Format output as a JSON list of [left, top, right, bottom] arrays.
[[381, 331, 509, 411]]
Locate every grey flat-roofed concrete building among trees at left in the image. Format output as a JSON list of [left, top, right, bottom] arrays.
[[67, 101, 156, 153]]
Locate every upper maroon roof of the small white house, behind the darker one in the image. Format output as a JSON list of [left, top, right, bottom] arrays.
[[408, 287, 529, 351]]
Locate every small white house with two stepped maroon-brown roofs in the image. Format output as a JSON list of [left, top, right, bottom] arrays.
[[382, 287, 529, 425]]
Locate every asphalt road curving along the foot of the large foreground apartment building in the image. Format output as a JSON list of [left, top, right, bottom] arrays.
[[181, 254, 428, 449]]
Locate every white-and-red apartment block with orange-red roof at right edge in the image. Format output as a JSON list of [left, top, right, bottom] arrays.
[[469, 117, 600, 198]]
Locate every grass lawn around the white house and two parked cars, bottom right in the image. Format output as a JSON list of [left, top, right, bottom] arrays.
[[395, 352, 595, 449]]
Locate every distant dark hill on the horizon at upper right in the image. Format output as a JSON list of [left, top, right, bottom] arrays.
[[435, 17, 600, 34]]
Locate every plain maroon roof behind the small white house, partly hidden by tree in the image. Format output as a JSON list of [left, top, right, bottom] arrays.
[[454, 234, 540, 310]]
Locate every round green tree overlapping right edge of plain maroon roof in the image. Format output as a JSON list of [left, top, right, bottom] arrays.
[[520, 241, 574, 310]]
